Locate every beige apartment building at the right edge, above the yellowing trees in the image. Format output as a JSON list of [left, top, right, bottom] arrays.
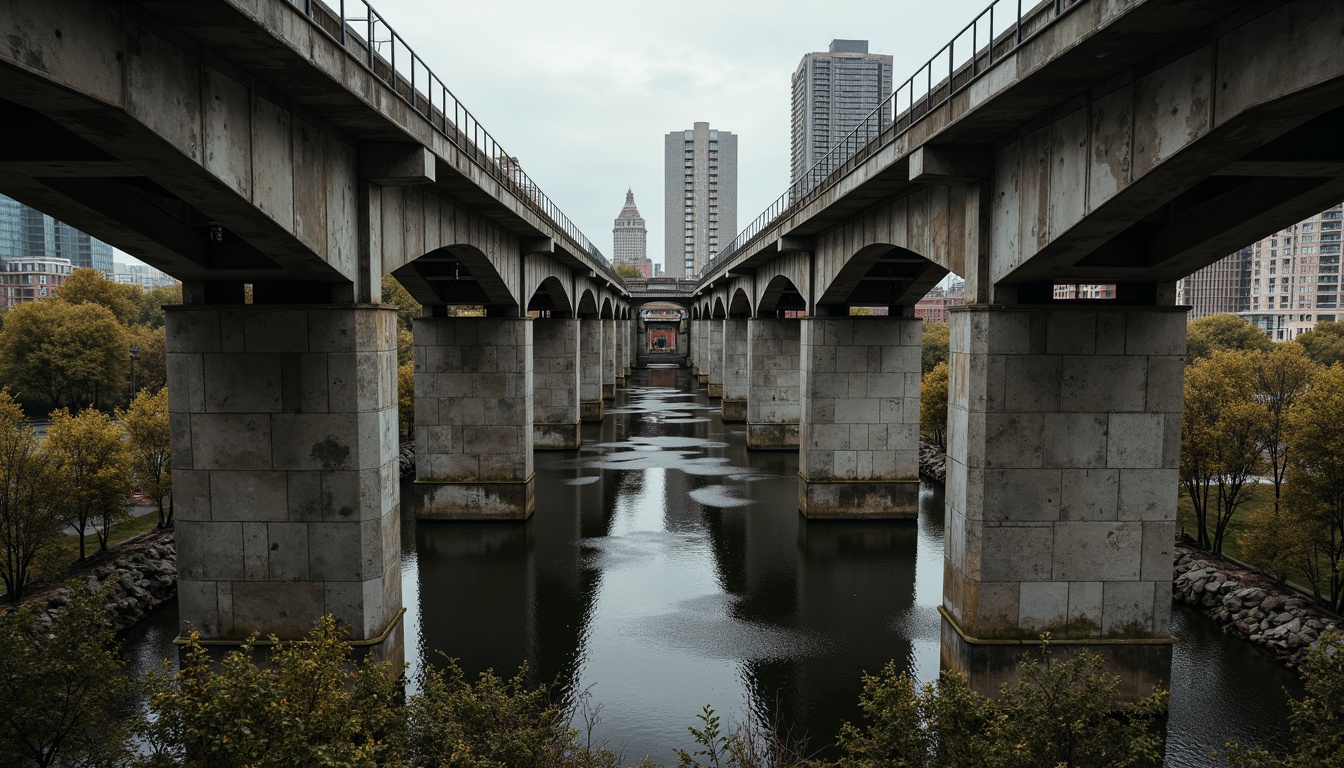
[[1239, 204, 1344, 342]]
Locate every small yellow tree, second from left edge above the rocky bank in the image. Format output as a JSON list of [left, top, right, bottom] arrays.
[[43, 408, 130, 560]]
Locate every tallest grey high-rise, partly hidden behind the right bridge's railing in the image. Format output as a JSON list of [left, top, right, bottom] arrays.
[[789, 40, 891, 183]]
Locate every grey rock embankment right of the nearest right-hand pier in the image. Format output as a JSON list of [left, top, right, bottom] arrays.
[[1172, 543, 1344, 667]]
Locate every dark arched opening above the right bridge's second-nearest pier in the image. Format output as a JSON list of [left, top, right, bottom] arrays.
[[817, 242, 948, 307]]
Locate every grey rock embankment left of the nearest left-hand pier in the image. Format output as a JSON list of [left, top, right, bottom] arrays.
[[15, 531, 177, 631]]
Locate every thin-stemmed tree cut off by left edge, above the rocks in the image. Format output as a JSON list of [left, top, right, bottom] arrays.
[[0, 390, 62, 599]]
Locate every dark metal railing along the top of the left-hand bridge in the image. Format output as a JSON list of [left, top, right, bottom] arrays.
[[285, 0, 620, 281]]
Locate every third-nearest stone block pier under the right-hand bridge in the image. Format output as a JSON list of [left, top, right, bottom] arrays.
[[747, 317, 801, 449]]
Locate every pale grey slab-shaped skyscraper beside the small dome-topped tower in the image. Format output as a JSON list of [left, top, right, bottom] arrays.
[[663, 122, 738, 277]]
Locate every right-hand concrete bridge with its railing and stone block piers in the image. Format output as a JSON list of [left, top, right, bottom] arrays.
[[677, 0, 1344, 667]]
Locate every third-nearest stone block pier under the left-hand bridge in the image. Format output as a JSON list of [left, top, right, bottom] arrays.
[[532, 317, 581, 451]]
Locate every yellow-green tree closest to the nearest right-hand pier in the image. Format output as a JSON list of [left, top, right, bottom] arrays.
[[1180, 351, 1270, 554]]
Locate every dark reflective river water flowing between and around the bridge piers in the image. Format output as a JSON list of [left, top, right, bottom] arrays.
[[126, 369, 1301, 767]]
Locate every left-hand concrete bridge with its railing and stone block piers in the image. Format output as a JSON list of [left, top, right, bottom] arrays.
[[0, 0, 634, 656]]
